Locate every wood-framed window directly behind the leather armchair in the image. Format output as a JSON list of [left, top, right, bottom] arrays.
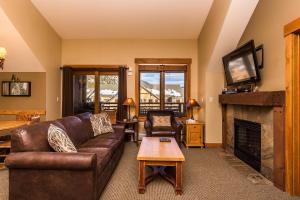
[[138, 65, 188, 117]]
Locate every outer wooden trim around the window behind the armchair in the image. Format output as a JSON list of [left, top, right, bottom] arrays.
[[135, 58, 192, 117]]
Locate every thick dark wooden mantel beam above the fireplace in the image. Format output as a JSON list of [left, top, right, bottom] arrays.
[[219, 91, 285, 106]]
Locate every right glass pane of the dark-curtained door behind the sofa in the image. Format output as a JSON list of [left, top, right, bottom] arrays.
[[100, 75, 119, 111]]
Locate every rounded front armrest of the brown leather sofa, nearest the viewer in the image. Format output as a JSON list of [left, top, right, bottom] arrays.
[[5, 152, 97, 170]]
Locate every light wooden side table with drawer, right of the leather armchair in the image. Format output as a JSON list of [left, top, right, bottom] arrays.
[[183, 121, 205, 148]]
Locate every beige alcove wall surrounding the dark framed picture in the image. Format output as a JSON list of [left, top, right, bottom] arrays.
[[0, 72, 46, 119]]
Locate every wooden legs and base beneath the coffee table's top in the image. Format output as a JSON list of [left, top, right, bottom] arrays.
[[138, 160, 182, 195]]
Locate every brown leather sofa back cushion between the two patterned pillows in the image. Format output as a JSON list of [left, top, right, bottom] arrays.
[[56, 116, 90, 147]]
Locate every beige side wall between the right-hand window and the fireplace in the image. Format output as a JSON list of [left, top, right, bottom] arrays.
[[198, 0, 231, 143]]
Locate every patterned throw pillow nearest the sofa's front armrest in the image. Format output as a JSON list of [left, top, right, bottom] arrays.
[[48, 124, 77, 153]]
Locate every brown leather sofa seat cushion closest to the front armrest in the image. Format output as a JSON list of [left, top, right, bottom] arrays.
[[78, 147, 112, 175]]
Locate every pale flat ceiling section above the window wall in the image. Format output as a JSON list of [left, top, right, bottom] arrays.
[[31, 0, 213, 39]]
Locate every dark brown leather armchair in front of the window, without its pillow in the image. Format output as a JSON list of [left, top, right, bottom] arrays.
[[144, 110, 183, 146]]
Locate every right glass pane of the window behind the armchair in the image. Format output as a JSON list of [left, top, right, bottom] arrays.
[[165, 72, 185, 116]]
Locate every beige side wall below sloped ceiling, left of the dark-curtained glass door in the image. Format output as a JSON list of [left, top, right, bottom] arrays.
[[0, 0, 61, 120]]
